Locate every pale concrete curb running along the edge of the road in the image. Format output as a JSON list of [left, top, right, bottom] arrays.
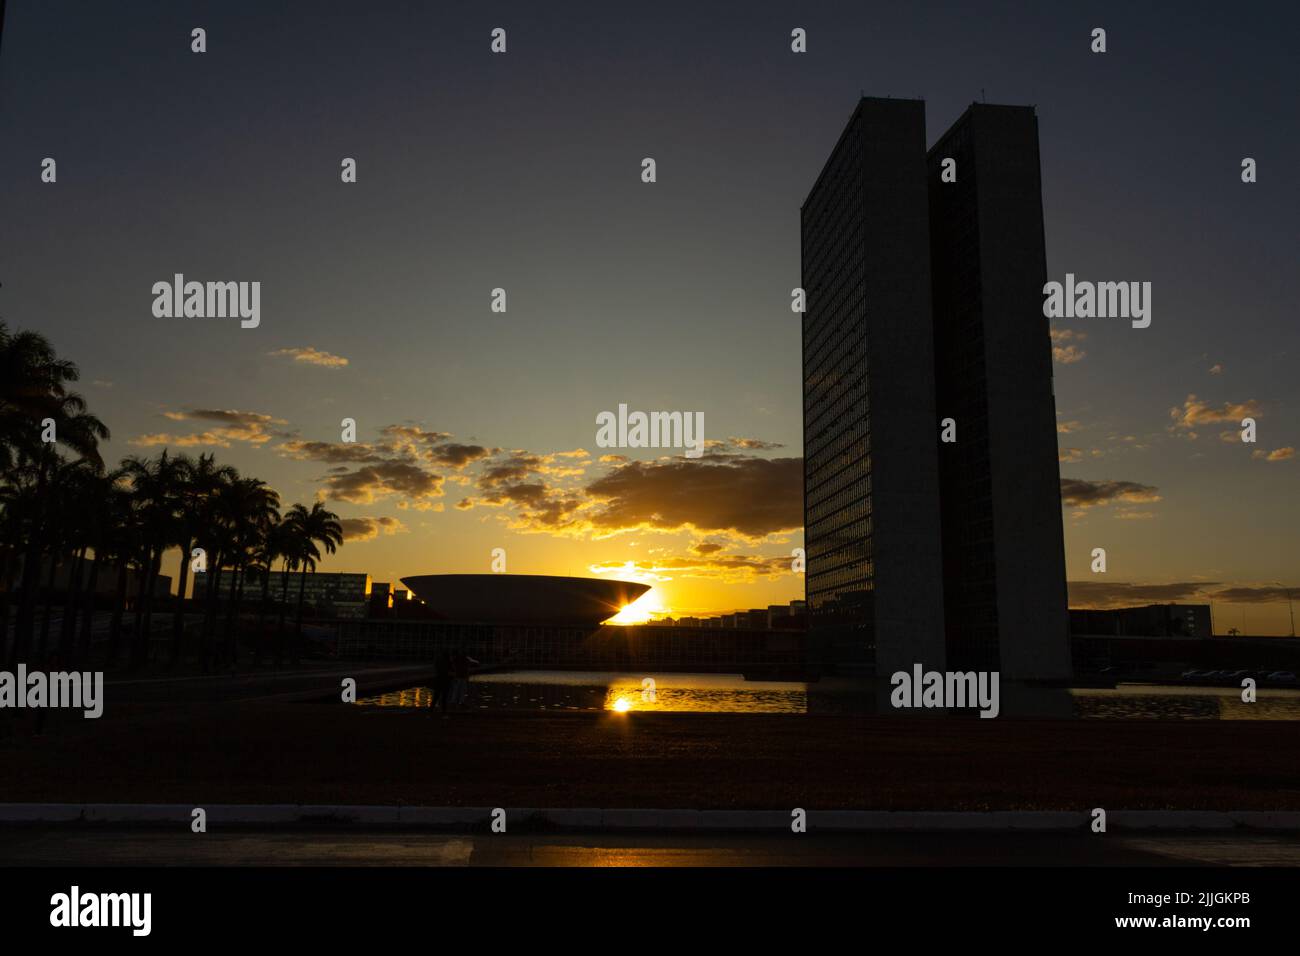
[[0, 804, 1300, 832]]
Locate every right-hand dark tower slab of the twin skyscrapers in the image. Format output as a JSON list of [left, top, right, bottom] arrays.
[[930, 103, 1070, 680]]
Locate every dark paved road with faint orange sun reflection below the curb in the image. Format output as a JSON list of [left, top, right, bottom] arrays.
[[0, 827, 1300, 866]]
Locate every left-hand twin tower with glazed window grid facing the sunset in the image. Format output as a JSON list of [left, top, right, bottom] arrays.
[[801, 99, 944, 672]]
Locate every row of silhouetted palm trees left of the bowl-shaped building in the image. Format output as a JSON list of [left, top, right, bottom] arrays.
[[0, 323, 343, 670]]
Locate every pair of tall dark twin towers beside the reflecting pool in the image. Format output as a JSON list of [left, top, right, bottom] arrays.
[[801, 98, 1070, 682]]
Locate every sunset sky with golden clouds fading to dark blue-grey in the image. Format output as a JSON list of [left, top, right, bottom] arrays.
[[0, 3, 1300, 633]]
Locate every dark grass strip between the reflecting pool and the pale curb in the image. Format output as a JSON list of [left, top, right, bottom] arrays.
[[0, 695, 1300, 810]]
